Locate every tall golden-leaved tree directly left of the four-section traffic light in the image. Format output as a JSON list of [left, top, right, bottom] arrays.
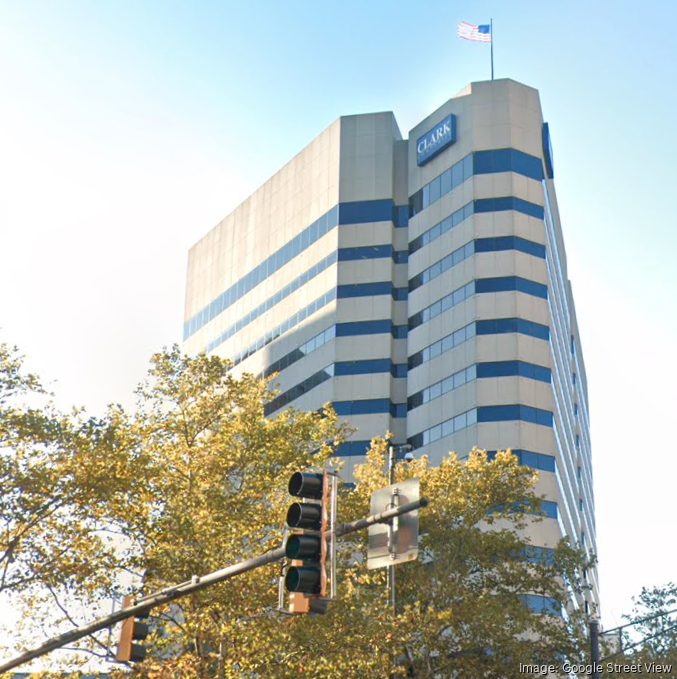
[[113, 347, 344, 675]]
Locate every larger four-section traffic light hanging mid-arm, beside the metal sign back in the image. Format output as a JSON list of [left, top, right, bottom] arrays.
[[284, 471, 335, 613]]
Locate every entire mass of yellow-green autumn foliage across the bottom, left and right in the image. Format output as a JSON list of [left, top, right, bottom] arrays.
[[0, 347, 587, 679]]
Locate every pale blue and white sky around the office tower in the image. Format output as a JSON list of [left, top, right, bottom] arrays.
[[0, 0, 677, 668]]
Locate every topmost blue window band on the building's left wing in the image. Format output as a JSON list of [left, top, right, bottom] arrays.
[[183, 199, 408, 340]]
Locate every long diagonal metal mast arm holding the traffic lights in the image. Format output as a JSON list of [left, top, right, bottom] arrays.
[[0, 497, 428, 673]]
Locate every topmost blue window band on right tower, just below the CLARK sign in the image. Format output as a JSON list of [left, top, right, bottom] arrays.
[[409, 149, 543, 217]]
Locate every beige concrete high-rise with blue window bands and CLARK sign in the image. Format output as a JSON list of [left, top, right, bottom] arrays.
[[184, 79, 598, 603]]
